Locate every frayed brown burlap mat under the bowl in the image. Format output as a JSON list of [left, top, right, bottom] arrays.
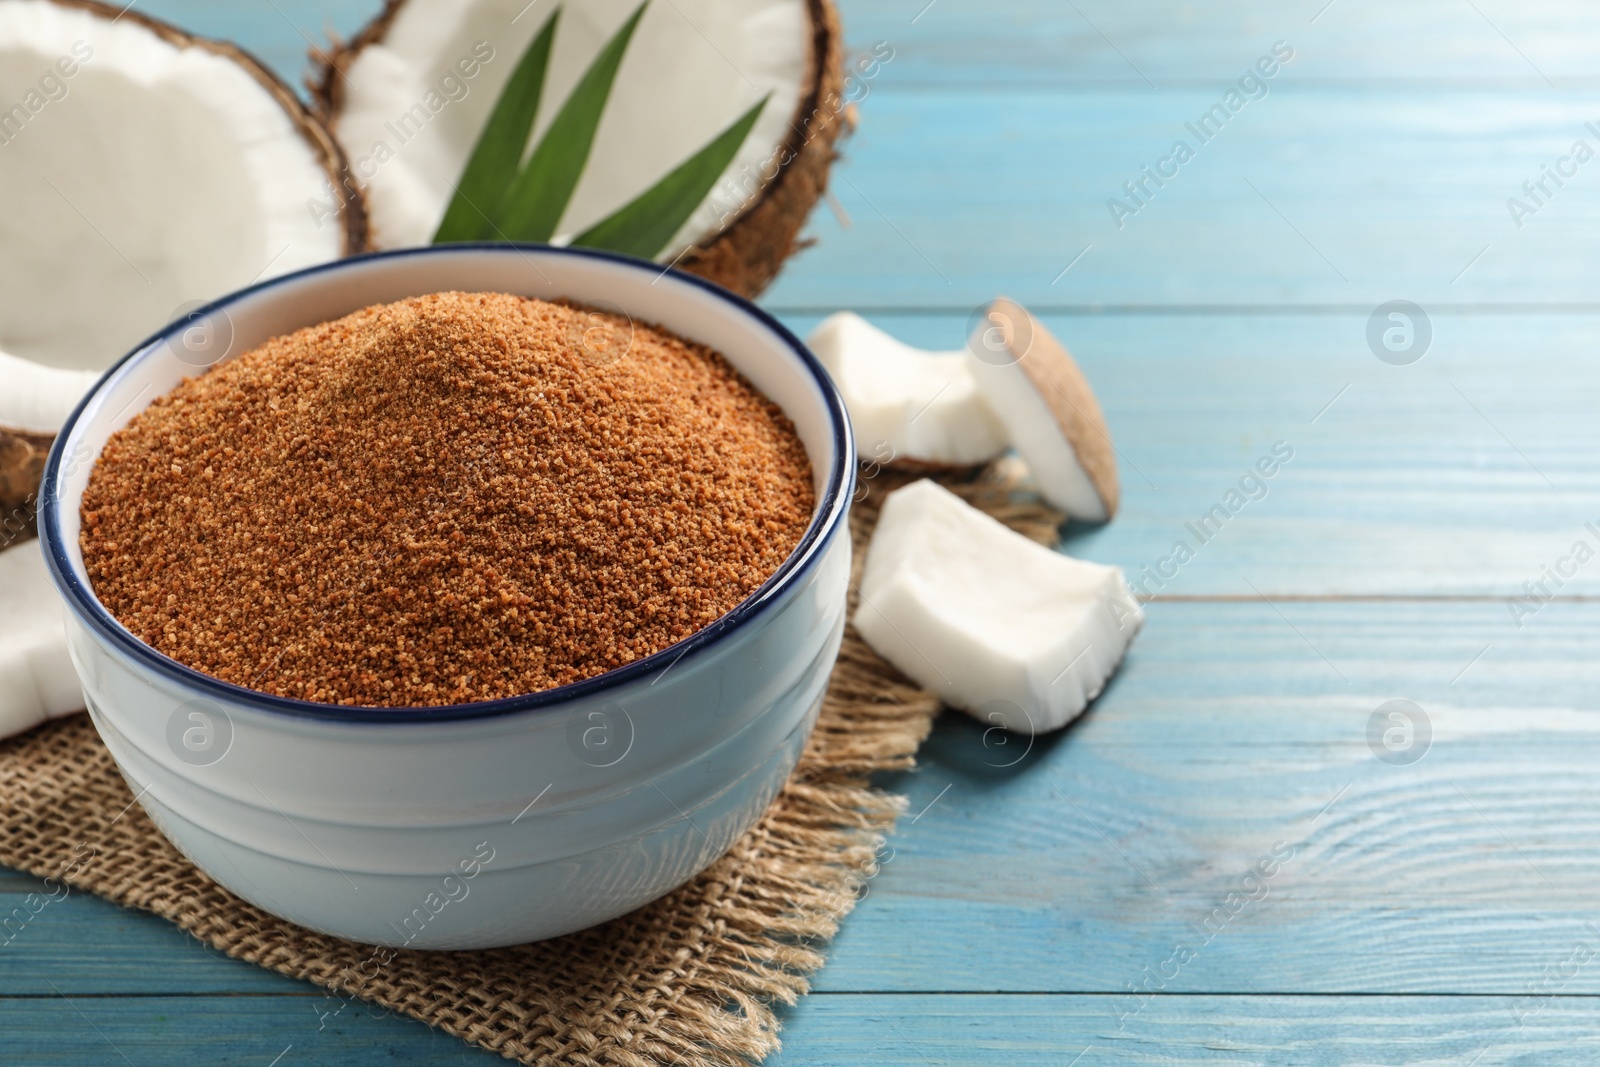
[[0, 467, 1059, 1067]]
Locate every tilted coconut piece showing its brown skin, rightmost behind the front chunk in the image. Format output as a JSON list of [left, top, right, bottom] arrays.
[[966, 298, 1122, 523]]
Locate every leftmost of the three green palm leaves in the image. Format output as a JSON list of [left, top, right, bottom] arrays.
[[434, 8, 562, 245]]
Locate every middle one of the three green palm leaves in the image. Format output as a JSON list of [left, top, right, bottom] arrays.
[[496, 0, 650, 242]]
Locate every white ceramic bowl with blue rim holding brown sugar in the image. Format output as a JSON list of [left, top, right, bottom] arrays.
[[38, 245, 856, 949]]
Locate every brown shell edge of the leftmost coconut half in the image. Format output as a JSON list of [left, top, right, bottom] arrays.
[[0, 0, 366, 517]]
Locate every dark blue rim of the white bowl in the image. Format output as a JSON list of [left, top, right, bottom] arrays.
[[38, 242, 856, 725]]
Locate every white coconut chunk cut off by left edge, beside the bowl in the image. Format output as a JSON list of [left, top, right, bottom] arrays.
[[0, 541, 83, 737]]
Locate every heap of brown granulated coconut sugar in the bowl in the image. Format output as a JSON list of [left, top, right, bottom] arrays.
[[80, 293, 814, 707]]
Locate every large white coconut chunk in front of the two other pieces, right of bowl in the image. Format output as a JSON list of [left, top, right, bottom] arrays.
[[854, 480, 1144, 733]]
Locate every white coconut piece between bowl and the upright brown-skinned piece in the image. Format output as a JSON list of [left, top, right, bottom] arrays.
[[806, 312, 1008, 467]]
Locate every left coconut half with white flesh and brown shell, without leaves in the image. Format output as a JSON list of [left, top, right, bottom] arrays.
[[0, 0, 365, 512]]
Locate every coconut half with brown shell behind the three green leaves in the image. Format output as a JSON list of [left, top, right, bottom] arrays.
[[315, 0, 850, 294]]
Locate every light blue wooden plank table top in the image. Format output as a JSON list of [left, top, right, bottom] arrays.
[[9, 0, 1600, 1067]]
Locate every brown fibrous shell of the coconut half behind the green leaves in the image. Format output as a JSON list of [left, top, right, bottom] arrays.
[[307, 0, 854, 298]]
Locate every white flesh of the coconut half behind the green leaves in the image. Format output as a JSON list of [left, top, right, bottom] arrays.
[[334, 0, 813, 261]]
